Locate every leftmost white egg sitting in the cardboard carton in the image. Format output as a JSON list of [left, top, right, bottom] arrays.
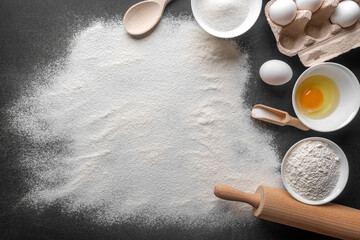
[[269, 0, 296, 26]]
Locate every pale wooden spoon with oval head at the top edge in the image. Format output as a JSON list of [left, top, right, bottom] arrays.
[[124, 0, 171, 36]]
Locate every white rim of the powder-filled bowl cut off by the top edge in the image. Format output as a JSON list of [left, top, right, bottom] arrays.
[[191, 0, 262, 38]]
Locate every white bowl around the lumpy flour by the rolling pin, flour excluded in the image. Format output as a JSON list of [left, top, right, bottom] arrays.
[[281, 137, 349, 205]]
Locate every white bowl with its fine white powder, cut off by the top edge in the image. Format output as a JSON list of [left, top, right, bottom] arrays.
[[191, 0, 262, 38]]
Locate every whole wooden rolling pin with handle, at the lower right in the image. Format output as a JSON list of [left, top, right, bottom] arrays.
[[214, 185, 360, 239]]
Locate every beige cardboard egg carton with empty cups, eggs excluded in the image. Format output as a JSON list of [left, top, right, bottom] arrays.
[[265, 0, 360, 67]]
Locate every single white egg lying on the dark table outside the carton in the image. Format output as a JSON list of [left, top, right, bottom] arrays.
[[259, 60, 293, 86]]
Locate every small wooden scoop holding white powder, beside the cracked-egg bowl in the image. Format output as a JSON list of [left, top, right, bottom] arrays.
[[251, 104, 310, 131]]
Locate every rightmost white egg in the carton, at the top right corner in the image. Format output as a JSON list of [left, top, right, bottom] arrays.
[[330, 1, 360, 27]]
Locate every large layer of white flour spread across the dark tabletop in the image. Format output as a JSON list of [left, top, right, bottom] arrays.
[[9, 18, 281, 228]]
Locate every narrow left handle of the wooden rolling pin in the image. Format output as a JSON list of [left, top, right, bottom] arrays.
[[214, 184, 260, 208]]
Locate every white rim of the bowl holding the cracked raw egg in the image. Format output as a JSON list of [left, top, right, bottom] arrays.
[[291, 62, 360, 132]]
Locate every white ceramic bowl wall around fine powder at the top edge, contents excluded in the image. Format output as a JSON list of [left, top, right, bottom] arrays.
[[191, 0, 262, 38]]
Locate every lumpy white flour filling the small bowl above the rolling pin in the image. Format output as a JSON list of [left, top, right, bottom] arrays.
[[284, 141, 340, 201]]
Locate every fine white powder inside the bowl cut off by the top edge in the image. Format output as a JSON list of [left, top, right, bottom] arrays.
[[198, 0, 249, 31]]
